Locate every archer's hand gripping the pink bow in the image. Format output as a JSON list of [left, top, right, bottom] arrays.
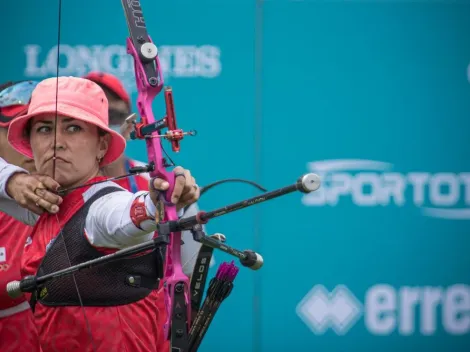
[[149, 166, 200, 210]]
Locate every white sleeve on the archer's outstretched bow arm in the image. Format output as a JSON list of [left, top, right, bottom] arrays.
[[85, 183, 185, 249]]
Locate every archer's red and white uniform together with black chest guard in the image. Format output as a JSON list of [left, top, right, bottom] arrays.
[[0, 159, 169, 352]]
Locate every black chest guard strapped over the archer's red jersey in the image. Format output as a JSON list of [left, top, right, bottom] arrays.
[[33, 187, 163, 306]]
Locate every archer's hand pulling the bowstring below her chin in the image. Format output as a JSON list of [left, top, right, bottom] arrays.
[[6, 173, 62, 215]]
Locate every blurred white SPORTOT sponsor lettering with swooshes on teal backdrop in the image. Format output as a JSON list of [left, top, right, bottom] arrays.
[[302, 159, 470, 220]]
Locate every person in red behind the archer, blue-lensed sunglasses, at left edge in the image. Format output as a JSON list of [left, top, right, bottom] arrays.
[[0, 81, 41, 352]]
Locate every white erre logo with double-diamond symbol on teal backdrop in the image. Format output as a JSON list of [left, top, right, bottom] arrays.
[[296, 284, 470, 336]]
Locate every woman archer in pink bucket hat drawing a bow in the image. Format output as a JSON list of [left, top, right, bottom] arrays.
[[0, 77, 199, 352]]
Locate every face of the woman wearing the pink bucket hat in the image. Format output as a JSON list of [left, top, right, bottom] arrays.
[[30, 115, 109, 188]]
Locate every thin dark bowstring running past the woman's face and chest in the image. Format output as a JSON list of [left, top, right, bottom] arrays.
[[52, 0, 96, 352]]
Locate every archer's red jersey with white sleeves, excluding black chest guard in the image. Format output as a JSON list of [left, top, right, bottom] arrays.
[[0, 159, 167, 352]]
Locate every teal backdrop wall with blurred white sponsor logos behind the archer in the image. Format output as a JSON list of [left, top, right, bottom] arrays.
[[0, 0, 470, 352]]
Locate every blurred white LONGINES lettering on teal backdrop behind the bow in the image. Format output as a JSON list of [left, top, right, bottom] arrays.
[[24, 44, 222, 94]]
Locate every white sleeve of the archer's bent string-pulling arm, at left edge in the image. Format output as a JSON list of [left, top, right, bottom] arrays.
[[0, 158, 39, 226]]
